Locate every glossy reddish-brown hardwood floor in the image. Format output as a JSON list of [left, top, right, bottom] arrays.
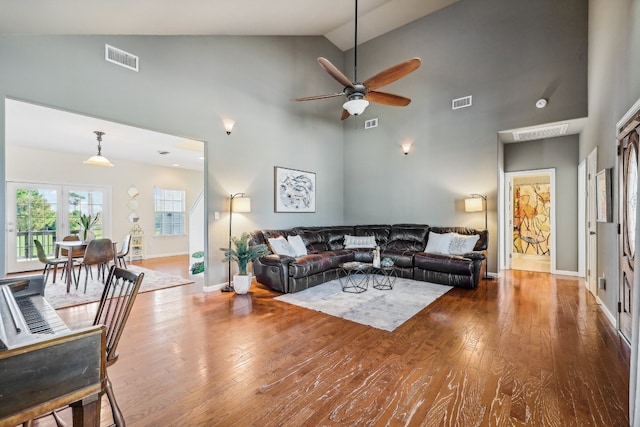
[[30, 258, 629, 427]]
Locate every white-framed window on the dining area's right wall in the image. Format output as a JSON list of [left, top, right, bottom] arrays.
[[153, 187, 185, 236]]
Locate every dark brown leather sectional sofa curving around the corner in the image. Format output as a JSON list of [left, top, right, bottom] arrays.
[[251, 224, 488, 293]]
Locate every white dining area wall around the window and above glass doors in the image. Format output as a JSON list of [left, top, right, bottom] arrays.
[[5, 145, 204, 258]]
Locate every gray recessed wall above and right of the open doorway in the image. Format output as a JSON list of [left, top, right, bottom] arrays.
[[504, 135, 579, 271]]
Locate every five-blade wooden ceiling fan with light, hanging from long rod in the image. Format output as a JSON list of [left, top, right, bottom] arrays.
[[295, 0, 422, 120]]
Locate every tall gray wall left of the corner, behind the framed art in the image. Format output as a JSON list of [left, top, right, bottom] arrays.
[[0, 36, 343, 284]]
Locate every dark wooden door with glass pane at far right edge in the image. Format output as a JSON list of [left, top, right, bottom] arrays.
[[618, 126, 639, 341]]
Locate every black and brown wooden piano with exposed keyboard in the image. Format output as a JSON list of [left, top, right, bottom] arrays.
[[0, 276, 106, 427]]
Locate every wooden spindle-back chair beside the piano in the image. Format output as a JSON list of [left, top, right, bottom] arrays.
[[53, 265, 144, 427]]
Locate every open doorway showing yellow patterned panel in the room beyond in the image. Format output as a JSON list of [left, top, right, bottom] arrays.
[[504, 169, 556, 273]]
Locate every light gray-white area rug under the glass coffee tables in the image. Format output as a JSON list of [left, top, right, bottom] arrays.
[[275, 278, 452, 332]]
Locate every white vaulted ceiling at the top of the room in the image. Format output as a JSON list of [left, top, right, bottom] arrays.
[[0, 0, 458, 51]]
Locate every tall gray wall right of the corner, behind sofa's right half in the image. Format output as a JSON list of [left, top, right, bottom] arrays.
[[344, 0, 587, 272]]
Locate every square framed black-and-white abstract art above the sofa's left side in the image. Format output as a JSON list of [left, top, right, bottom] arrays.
[[273, 166, 316, 212]]
